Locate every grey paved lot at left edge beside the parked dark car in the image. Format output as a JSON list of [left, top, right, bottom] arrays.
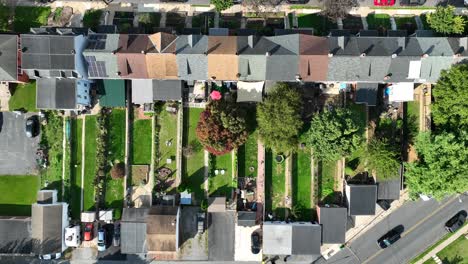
[[0, 112, 40, 175]]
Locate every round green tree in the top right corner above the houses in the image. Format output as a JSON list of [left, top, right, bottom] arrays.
[[427, 5, 466, 35]]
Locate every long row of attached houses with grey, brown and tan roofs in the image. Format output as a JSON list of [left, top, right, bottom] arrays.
[[0, 28, 468, 109]]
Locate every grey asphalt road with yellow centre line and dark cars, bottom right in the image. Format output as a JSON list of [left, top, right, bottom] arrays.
[[316, 195, 468, 264]]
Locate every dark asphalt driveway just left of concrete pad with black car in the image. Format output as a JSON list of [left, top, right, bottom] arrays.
[[208, 212, 236, 261]]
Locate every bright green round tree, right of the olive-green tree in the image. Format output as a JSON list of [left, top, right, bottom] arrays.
[[307, 108, 363, 160]]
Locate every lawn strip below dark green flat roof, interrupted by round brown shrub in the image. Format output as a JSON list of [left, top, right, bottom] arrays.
[[106, 109, 125, 215]]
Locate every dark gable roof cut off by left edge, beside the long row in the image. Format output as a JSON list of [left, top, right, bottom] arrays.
[[0, 35, 18, 81]]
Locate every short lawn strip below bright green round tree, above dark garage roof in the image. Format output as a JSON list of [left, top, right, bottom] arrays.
[[318, 161, 336, 203]]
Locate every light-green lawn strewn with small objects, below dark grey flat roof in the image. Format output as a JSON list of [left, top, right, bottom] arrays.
[[157, 106, 177, 173]]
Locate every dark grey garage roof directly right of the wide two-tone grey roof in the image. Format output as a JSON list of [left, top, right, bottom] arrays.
[[318, 206, 348, 244]]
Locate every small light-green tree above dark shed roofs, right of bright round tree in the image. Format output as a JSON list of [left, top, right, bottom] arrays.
[[362, 139, 400, 179]]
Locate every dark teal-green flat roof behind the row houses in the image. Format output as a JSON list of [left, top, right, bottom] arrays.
[[99, 80, 125, 107]]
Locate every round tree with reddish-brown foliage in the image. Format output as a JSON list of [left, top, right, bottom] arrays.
[[197, 100, 248, 155]]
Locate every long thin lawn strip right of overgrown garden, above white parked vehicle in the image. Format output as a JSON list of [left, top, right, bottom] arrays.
[[70, 119, 83, 219]]
